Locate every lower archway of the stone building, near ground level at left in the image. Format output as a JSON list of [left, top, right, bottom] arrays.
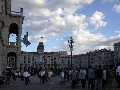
[[7, 52, 17, 69]]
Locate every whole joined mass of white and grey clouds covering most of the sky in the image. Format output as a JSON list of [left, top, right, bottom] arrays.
[[12, 0, 120, 54]]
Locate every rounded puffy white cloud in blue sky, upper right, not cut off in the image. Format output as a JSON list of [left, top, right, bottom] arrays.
[[89, 11, 107, 30]]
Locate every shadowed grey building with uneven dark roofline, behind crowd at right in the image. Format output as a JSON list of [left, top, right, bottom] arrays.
[[89, 49, 114, 67]]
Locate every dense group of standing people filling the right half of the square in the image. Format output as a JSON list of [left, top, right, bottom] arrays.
[[60, 63, 120, 90]]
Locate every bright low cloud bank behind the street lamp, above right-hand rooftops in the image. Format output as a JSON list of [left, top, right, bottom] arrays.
[[53, 30, 120, 54]]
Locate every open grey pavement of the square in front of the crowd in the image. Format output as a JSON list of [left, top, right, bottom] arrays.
[[0, 76, 120, 90]]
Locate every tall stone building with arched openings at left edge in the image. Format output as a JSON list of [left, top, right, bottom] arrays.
[[0, 0, 24, 73]]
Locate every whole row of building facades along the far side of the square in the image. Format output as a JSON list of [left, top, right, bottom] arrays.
[[21, 42, 114, 69]]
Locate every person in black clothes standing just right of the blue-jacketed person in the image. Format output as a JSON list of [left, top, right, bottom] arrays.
[[96, 66, 103, 89]]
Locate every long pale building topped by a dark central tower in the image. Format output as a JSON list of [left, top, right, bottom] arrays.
[[20, 42, 67, 68]]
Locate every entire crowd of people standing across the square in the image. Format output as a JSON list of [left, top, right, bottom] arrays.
[[0, 63, 120, 90]]
